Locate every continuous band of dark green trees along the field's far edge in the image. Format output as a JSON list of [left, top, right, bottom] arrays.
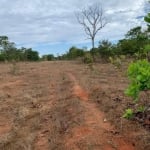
[[0, 24, 150, 61]]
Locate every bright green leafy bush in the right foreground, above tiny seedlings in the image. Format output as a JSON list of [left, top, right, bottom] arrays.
[[125, 60, 150, 101]]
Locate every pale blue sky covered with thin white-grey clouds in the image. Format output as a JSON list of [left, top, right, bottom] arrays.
[[0, 0, 150, 55]]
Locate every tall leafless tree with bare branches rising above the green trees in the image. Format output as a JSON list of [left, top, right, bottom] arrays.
[[76, 4, 107, 48]]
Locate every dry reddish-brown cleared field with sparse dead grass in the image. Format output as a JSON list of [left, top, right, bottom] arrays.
[[0, 61, 150, 150]]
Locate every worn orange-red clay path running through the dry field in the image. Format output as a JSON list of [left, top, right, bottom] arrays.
[[65, 73, 135, 150]]
